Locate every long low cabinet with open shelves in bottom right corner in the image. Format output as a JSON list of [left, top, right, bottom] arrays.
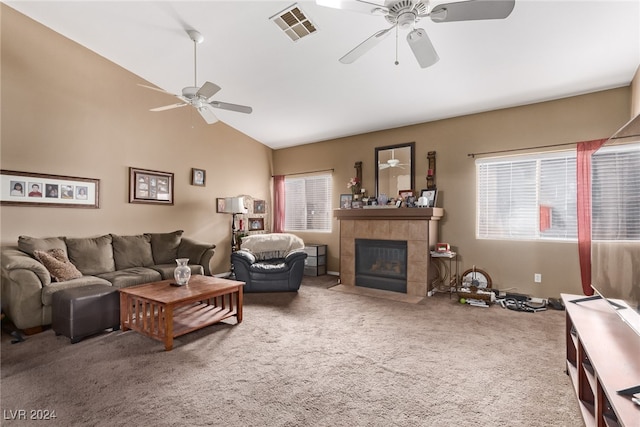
[[562, 294, 640, 427]]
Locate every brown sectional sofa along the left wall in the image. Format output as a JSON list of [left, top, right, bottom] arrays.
[[1, 230, 215, 330]]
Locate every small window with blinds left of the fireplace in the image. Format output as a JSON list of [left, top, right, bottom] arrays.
[[284, 174, 332, 233]]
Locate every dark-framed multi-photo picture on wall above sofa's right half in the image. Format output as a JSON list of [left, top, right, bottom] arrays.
[[129, 167, 173, 205]]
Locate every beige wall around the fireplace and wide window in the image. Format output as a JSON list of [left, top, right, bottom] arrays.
[[274, 87, 630, 297]]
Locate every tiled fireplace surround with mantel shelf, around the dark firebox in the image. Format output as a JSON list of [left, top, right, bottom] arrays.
[[333, 208, 444, 296]]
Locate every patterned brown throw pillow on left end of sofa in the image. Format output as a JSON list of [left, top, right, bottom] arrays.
[[65, 234, 116, 276]]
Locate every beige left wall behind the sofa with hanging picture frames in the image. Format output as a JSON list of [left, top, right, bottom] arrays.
[[0, 4, 272, 273]]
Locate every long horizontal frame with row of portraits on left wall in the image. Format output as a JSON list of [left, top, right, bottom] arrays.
[[0, 170, 100, 209]]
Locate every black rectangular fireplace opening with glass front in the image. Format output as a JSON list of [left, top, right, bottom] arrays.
[[356, 239, 407, 294]]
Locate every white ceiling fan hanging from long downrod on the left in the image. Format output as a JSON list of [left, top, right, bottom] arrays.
[[139, 30, 253, 124]]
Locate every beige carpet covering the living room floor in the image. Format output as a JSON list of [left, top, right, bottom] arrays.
[[0, 276, 583, 427]]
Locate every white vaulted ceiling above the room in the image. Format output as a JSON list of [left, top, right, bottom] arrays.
[[4, 0, 640, 149]]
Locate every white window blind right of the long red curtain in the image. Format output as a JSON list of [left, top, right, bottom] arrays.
[[591, 143, 640, 241]]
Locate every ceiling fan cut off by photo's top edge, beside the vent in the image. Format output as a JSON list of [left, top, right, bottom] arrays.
[[316, 0, 515, 68]]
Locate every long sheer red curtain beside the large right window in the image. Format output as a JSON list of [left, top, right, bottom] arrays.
[[576, 139, 607, 295]]
